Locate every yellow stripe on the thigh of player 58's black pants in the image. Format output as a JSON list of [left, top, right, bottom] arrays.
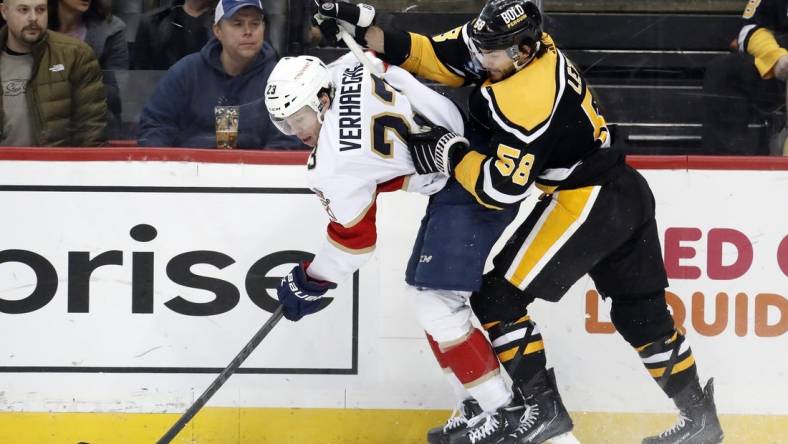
[[510, 187, 594, 288]]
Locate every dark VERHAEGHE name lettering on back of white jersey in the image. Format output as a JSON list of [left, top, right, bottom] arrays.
[[339, 63, 364, 151]]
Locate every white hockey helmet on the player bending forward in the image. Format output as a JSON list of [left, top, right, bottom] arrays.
[[265, 56, 333, 135]]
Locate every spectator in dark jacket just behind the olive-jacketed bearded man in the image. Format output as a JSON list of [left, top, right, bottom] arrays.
[[47, 0, 129, 138]]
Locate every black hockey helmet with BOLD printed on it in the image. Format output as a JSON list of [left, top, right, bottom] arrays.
[[470, 0, 542, 50]]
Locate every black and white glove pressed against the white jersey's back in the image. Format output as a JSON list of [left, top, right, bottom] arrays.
[[408, 126, 470, 176]]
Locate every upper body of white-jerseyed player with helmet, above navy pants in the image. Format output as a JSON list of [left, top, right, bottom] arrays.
[[266, 55, 456, 290]]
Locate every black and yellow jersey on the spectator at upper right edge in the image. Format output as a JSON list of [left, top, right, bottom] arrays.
[[737, 0, 788, 79]]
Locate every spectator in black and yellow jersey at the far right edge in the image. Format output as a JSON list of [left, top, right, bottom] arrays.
[[703, 0, 788, 155]]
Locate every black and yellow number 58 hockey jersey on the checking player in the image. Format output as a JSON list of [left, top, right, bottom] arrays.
[[386, 24, 623, 208]]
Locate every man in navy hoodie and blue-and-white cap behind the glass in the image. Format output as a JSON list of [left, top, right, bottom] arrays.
[[138, 0, 305, 149]]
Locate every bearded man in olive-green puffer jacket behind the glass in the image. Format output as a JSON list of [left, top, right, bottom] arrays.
[[0, 0, 107, 146]]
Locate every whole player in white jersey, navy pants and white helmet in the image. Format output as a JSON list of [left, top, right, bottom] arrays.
[[265, 54, 528, 443]]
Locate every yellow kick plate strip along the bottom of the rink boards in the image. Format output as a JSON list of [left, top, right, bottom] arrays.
[[0, 408, 788, 444]]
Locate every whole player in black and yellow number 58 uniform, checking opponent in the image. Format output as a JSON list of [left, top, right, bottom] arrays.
[[321, 0, 723, 444]]
